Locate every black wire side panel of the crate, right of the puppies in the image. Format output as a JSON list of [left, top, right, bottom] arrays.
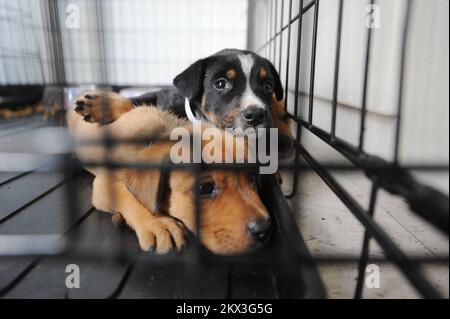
[[249, 0, 449, 298]]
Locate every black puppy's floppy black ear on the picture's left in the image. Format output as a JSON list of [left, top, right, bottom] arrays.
[[173, 59, 206, 100]]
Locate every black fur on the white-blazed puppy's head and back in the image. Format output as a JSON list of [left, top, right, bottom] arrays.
[[132, 49, 283, 128]]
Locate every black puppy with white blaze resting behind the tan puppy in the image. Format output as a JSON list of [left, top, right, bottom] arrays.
[[132, 49, 293, 154]]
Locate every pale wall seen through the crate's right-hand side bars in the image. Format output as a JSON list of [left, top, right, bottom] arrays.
[[250, 0, 449, 169]]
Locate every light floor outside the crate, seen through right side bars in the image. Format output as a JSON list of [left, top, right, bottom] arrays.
[[283, 171, 449, 298]]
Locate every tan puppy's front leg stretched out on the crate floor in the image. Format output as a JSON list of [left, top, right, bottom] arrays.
[[92, 173, 185, 254]]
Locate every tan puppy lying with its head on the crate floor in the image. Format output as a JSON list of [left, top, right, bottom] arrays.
[[67, 92, 271, 254]]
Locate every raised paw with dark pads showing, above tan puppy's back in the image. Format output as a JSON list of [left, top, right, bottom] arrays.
[[75, 91, 133, 124]]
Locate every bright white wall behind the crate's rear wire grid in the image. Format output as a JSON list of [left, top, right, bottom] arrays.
[[0, 0, 247, 86]]
